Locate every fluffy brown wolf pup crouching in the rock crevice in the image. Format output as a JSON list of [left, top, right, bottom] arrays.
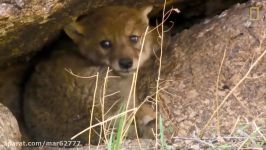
[[24, 6, 159, 146]]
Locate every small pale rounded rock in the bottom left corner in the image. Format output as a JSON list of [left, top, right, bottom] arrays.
[[0, 103, 21, 150]]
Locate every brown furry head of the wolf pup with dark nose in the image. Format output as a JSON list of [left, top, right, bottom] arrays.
[[65, 6, 155, 75]]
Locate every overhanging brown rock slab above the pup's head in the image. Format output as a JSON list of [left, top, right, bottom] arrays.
[[0, 0, 180, 66]]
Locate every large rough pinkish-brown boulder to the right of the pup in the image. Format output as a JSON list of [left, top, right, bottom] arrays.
[[139, 0, 266, 140]]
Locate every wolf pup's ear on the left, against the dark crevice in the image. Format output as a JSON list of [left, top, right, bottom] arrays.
[[64, 22, 83, 43]]
